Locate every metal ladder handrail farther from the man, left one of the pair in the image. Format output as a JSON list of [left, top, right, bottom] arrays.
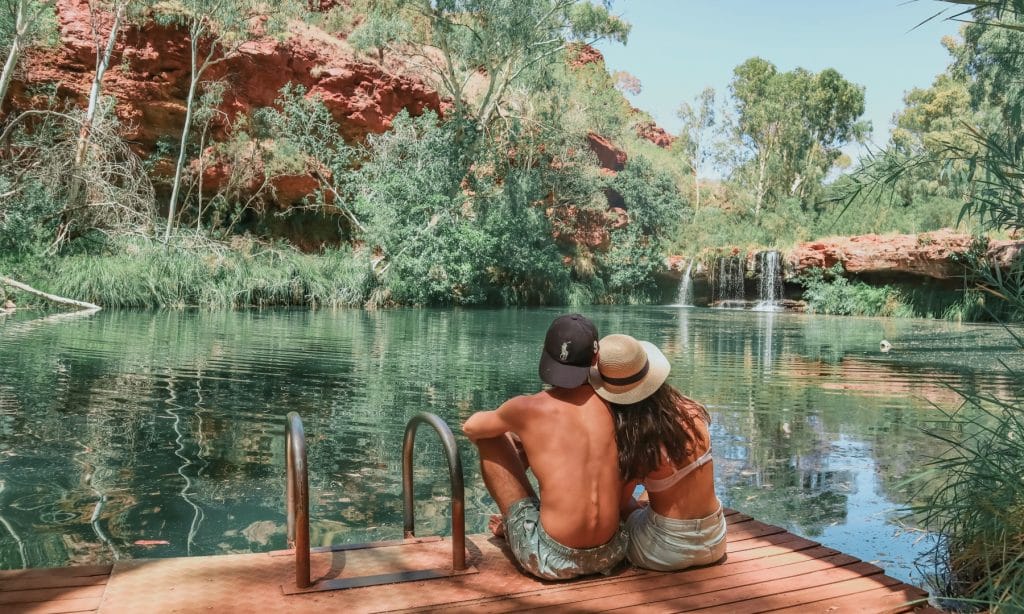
[[285, 411, 312, 588]]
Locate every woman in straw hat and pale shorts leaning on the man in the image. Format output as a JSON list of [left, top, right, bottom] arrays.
[[590, 335, 726, 571]]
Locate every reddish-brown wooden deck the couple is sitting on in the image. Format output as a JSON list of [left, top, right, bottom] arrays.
[[0, 512, 937, 614]]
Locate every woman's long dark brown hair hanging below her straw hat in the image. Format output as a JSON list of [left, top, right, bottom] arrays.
[[610, 382, 711, 482]]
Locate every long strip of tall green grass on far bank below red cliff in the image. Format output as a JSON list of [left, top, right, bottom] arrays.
[[0, 234, 375, 309]]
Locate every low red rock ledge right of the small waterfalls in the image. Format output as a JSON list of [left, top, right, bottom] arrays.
[[786, 229, 1007, 279]]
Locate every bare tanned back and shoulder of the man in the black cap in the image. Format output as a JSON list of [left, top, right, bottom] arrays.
[[463, 385, 622, 547]]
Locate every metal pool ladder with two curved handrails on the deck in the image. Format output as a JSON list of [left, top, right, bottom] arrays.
[[282, 411, 477, 594]]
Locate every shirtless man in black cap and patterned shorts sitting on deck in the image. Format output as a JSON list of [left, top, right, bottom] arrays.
[[462, 314, 627, 580]]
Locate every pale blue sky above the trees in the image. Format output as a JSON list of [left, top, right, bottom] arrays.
[[597, 0, 957, 156]]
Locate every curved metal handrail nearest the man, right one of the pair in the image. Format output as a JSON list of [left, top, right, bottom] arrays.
[[401, 411, 466, 571]]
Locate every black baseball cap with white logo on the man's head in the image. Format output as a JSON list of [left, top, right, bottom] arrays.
[[539, 313, 598, 388]]
